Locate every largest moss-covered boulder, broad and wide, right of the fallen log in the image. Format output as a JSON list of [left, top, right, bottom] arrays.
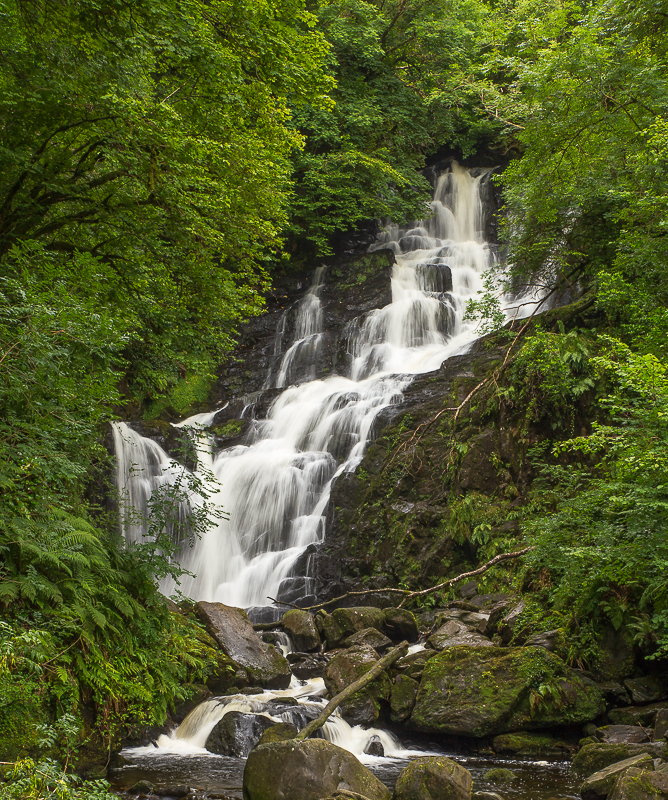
[[411, 647, 605, 737]]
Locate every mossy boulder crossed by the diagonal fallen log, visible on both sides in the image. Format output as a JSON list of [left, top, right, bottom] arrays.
[[323, 646, 391, 725]]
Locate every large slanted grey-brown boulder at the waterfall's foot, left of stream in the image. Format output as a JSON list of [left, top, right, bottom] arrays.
[[195, 601, 292, 689]]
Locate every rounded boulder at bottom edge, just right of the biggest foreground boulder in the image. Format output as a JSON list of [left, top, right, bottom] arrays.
[[394, 756, 472, 800]]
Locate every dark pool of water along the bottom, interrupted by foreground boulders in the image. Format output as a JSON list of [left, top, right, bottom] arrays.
[[110, 748, 579, 800]]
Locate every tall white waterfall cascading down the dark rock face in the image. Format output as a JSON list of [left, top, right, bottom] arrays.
[[114, 162, 493, 607]]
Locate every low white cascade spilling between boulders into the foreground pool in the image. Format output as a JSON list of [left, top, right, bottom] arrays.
[[125, 678, 434, 763]]
